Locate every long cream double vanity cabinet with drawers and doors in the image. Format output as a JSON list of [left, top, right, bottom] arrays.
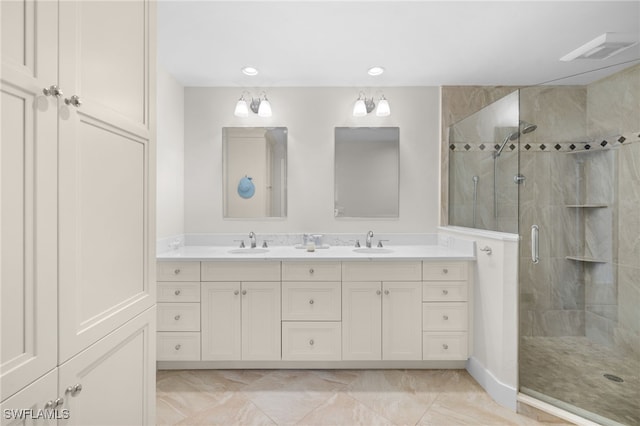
[[157, 250, 471, 368]]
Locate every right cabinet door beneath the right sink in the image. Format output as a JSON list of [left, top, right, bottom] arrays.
[[382, 282, 422, 360]]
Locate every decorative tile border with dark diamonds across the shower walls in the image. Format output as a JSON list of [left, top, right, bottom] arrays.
[[449, 132, 640, 152]]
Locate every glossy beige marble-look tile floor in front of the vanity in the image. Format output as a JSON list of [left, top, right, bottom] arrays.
[[157, 370, 568, 426]]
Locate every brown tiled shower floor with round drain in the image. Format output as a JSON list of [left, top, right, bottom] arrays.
[[520, 337, 640, 425]]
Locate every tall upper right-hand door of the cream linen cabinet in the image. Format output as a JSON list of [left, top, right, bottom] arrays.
[[58, 0, 155, 362]]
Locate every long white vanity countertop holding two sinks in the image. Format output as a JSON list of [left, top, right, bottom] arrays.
[[156, 245, 476, 261]]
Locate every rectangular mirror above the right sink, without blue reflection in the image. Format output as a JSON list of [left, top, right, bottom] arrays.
[[334, 127, 400, 218]]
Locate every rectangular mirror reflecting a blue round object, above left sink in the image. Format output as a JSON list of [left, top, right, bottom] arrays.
[[222, 127, 287, 219]]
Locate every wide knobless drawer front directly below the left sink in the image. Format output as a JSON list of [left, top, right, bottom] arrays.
[[202, 261, 280, 281]]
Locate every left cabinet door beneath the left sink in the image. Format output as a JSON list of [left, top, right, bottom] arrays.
[[200, 282, 241, 361]]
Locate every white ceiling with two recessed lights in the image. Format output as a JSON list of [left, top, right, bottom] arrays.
[[157, 0, 640, 87]]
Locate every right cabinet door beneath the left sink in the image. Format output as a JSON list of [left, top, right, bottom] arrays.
[[242, 282, 282, 360]]
